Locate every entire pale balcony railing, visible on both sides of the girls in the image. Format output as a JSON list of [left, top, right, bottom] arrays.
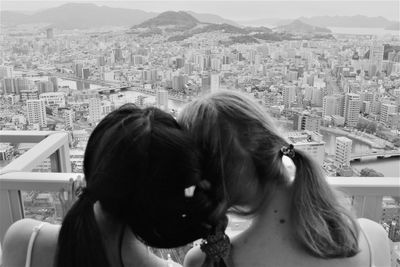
[[0, 131, 400, 246]]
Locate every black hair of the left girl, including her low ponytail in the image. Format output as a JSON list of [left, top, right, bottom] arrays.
[[55, 104, 212, 267]]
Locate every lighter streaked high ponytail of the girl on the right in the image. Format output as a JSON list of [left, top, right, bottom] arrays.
[[292, 150, 359, 258]]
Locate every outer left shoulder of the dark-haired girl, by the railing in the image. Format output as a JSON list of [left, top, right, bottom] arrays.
[[3, 219, 59, 266]]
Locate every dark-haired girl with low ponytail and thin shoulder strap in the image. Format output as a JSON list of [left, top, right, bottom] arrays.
[[3, 105, 212, 267]]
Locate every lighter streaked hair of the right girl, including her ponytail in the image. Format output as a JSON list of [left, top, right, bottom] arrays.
[[178, 91, 358, 266]]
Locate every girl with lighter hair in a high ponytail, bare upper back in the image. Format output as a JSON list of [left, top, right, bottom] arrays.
[[178, 91, 390, 267]]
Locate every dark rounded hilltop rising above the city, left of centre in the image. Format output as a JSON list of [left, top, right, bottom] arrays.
[[134, 11, 200, 28]]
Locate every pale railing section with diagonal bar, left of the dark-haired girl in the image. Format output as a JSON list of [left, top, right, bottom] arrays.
[[0, 131, 71, 242]]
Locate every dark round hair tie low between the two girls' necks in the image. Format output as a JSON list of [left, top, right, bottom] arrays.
[[200, 230, 231, 260]]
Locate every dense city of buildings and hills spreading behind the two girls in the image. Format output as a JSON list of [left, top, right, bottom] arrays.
[[0, 2, 400, 266]]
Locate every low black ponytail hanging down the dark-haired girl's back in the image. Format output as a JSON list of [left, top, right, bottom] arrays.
[[55, 193, 109, 267]]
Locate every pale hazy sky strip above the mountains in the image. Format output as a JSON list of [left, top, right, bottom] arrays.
[[0, 0, 400, 21]]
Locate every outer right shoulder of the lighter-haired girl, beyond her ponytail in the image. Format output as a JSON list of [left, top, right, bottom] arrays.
[[358, 219, 390, 266]]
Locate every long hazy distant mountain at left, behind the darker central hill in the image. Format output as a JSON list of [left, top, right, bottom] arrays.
[[1, 3, 156, 29]]
